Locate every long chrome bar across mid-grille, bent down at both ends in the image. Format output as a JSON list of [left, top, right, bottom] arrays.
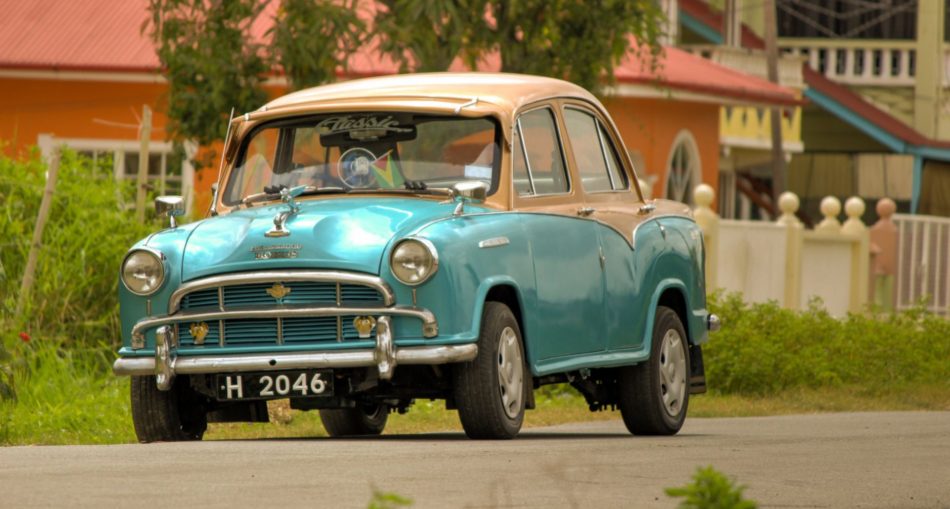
[[132, 306, 439, 348]]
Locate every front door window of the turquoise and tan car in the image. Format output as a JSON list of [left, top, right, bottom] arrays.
[[512, 108, 570, 196]]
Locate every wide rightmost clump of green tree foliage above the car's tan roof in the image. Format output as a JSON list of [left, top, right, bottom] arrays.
[[375, 0, 665, 91]]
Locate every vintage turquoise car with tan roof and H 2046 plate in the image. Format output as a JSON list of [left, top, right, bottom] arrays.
[[114, 73, 719, 442]]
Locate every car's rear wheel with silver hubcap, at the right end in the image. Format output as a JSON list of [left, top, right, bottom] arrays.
[[619, 306, 689, 435]]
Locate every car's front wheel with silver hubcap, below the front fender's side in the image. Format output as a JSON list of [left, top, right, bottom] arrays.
[[454, 302, 527, 439]]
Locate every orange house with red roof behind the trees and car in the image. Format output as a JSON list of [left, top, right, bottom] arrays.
[[0, 0, 798, 216]]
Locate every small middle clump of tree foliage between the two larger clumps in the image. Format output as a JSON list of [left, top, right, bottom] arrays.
[[269, 0, 366, 89]]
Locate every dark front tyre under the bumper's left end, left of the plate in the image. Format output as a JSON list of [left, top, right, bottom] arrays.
[[131, 376, 208, 443]]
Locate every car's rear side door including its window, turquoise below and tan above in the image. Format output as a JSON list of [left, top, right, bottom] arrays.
[[562, 103, 655, 350]]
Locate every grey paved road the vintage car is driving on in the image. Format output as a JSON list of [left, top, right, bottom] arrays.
[[0, 412, 950, 509]]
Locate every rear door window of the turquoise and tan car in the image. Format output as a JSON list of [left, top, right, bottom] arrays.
[[564, 108, 627, 192]]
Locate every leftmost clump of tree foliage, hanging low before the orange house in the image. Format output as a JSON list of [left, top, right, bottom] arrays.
[[148, 0, 268, 145]]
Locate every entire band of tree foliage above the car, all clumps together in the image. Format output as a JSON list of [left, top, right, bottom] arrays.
[[144, 0, 664, 151]]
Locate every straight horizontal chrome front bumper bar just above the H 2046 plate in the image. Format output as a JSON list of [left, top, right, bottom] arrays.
[[112, 343, 478, 376]]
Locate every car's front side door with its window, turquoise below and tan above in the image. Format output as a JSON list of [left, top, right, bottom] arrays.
[[512, 104, 606, 362]]
